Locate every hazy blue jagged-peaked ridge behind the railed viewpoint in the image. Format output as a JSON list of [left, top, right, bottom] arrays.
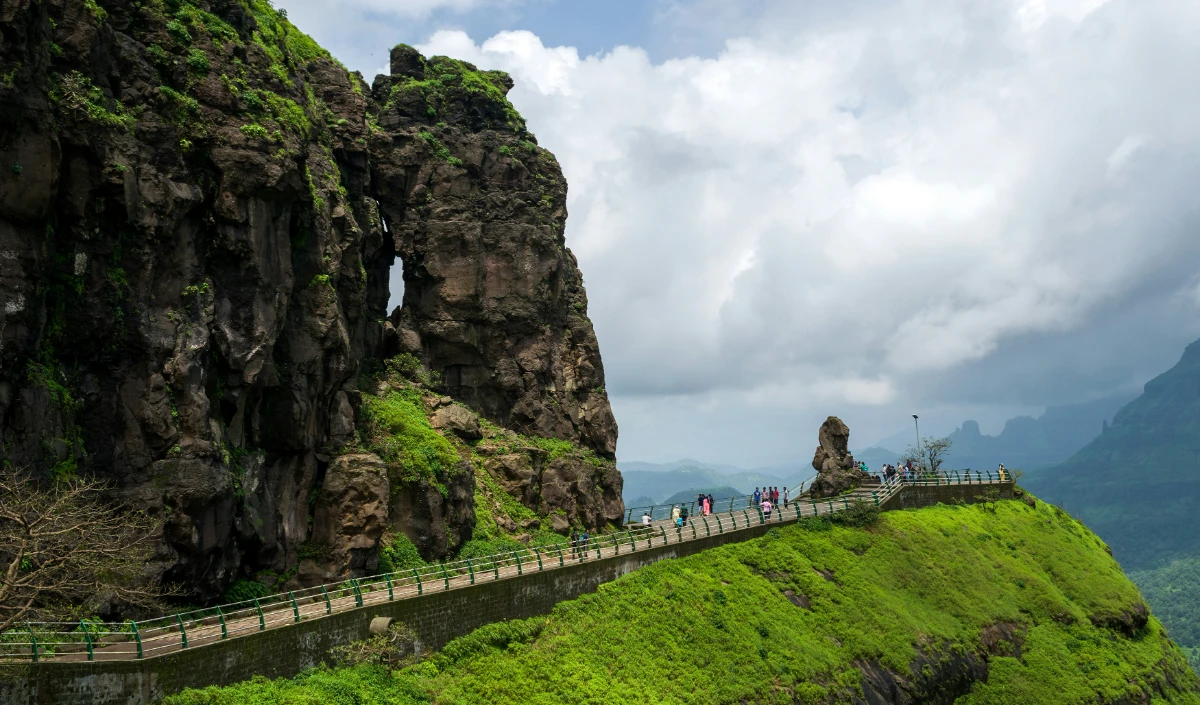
[[854, 394, 1133, 471]]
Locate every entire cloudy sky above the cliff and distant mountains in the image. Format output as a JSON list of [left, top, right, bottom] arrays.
[[278, 0, 1200, 466]]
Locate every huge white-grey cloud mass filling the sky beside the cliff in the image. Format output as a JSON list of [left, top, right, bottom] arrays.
[[400, 0, 1200, 462]]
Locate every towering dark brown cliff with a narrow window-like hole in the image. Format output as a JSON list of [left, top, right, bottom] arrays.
[[0, 0, 620, 598]]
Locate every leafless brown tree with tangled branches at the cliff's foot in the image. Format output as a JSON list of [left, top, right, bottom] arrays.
[[0, 470, 170, 633]]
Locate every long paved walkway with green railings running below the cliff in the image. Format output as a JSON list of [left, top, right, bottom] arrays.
[[0, 471, 1012, 663]]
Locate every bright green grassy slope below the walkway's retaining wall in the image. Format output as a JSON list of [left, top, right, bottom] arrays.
[[167, 501, 1200, 705]]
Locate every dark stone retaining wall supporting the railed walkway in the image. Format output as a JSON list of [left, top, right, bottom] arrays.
[[0, 483, 1013, 705]]
